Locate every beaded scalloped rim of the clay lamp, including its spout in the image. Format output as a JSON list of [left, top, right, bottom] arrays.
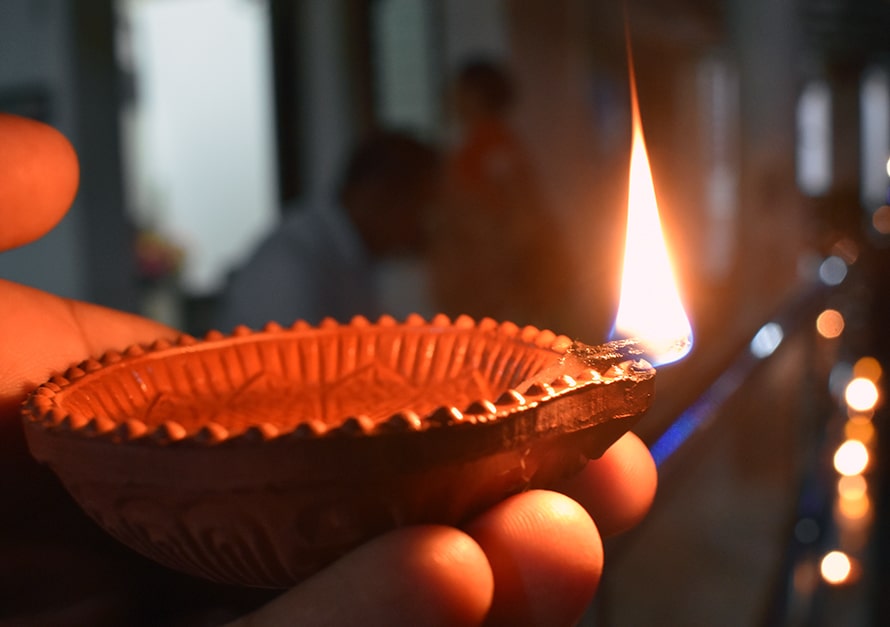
[[24, 314, 654, 446]]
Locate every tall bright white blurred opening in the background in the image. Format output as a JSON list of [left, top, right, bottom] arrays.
[[125, 0, 278, 295]]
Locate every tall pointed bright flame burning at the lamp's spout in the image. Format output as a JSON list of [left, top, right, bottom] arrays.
[[613, 45, 692, 366]]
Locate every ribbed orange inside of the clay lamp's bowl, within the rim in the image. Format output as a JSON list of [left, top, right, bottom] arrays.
[[38, 319, 570, 441]]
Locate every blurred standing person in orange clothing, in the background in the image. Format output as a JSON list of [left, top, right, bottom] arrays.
[[433, 58, 570, 326]]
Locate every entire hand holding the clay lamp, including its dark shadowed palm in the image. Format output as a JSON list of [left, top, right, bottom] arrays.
[[0, 114, 656, 627]]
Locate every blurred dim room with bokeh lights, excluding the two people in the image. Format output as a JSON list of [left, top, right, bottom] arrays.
[[0, 0, 890, 626]]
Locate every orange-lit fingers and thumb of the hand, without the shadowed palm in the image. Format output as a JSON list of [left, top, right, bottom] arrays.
[[0, 114, 656, 627]]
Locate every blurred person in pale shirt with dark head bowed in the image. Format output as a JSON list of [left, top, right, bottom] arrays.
[[217, 131, 441, 330]]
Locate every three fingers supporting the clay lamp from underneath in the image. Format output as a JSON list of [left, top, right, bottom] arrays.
[[230, 434, 656, 627]]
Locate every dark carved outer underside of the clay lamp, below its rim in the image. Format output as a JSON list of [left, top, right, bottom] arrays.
[[59, 432, 600, 588]]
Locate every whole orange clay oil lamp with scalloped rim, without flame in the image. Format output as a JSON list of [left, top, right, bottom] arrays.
[[24, 316, 655, 587]]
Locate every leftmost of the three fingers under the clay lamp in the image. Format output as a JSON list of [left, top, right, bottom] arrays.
[[228, 526, 494, 627]]
